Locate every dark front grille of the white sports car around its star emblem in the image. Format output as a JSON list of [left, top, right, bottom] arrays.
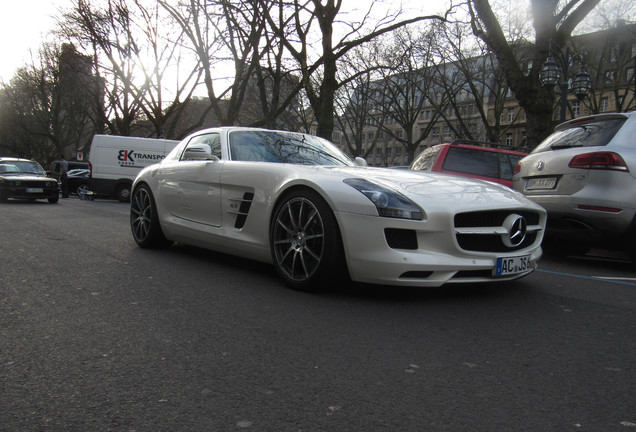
[[455, 210, 540, 252]]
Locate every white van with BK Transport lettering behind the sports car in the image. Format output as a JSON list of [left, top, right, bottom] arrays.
[[88, 135, 179, 202]]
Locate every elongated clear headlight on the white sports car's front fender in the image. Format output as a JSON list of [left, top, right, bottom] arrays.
[[344, 178, 424, 220]]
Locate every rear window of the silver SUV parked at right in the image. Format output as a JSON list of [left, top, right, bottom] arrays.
[[532, 118, 625, 153]]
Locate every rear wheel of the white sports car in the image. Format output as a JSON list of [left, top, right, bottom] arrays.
[[130, 184, 172, 248]]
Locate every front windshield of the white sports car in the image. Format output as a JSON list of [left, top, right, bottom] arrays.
[[230, 131, 354, 166]]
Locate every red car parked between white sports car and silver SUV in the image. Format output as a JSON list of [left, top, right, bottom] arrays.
[[410, 141, 528, 187]]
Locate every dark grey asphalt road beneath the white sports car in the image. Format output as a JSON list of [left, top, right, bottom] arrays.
[[0, 199, 636, 432]]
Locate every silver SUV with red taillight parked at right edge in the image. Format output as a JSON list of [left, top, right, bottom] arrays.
[[513, 112, 636, 261]]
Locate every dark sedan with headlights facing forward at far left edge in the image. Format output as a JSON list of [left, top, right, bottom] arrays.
[[0, 157, 60, 203]]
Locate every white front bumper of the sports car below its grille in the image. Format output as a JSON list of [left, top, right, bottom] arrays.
[[336, 213, 545, 287]]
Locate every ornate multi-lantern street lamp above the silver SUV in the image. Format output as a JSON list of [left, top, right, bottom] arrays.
[[539, 41, 592, 122]]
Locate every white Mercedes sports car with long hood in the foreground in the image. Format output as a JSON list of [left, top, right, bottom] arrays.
[[130, 127, 546, 290]]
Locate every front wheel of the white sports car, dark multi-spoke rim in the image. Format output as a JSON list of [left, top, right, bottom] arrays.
[[270, 190, 346, 291]]
